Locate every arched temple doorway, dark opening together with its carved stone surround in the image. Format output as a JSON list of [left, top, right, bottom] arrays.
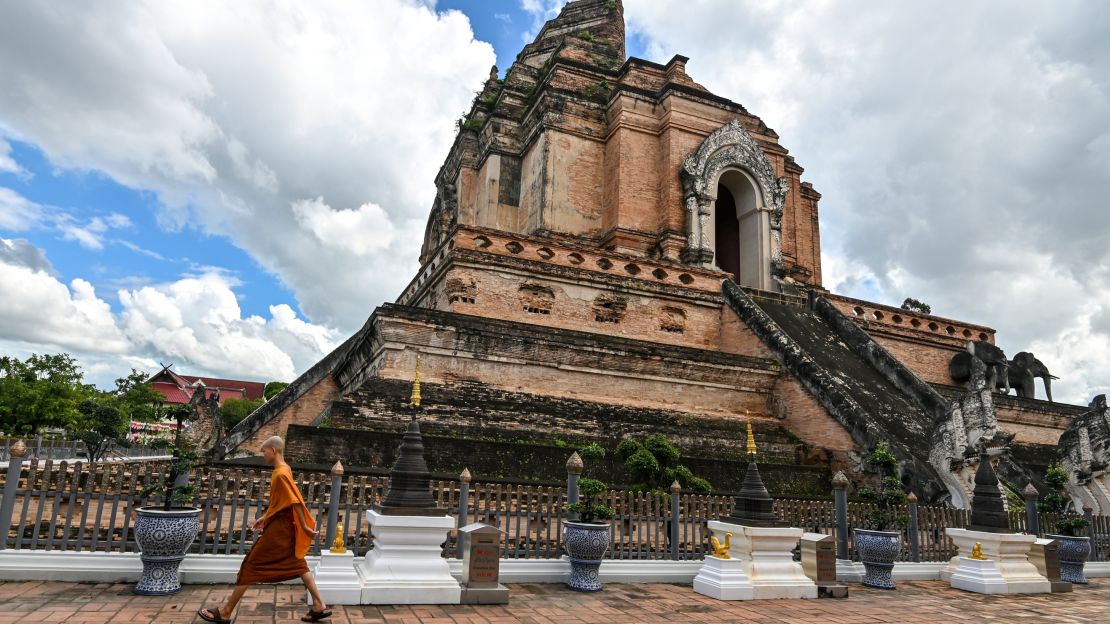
[[682, 120, 789, 291]]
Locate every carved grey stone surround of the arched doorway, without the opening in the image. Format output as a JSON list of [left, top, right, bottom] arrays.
[[680, 119, 790, 276]]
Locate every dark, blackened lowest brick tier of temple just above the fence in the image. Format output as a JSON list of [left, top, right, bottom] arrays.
[[285, 425, 830, 496]]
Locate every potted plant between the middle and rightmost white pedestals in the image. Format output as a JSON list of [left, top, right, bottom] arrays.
[[852, 442, 909, 590]]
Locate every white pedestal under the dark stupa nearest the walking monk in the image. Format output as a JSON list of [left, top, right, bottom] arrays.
[[359, 510, 462, 604]]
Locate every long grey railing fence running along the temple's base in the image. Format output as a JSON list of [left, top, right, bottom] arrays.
[[0, 459, 1110, 561]]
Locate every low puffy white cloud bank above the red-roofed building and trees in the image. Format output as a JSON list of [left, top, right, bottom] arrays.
[[0, 239, 340, 386]]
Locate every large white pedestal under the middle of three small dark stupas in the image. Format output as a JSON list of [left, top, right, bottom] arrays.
[[710, 520, 817, 600]]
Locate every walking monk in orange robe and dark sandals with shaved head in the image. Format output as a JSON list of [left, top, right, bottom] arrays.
[[196, 436, 332, 624]]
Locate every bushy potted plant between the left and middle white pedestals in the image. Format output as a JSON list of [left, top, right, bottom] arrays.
[[563, 443, 613, 592]]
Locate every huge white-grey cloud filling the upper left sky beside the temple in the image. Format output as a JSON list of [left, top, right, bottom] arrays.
[[0, 0, 495, 332]]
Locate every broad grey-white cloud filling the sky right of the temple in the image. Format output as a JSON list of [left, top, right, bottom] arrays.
[[625, 0, 1110, 404]]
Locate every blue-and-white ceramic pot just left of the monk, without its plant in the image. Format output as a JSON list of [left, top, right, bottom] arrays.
[[132, 507, 201, 596]]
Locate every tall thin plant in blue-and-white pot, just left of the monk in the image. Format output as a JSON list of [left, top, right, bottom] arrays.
[[133, 405, 201, 596]]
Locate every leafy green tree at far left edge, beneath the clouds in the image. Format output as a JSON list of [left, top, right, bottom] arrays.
[[0, 353, 98, 434]]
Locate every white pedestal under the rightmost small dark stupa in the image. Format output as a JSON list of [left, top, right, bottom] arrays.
[[940, 529, 1052, 594]]
